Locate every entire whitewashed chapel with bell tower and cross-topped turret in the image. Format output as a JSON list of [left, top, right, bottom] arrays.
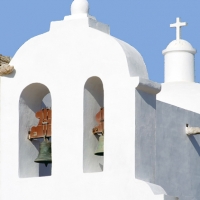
[[0, 0, 200, 200]]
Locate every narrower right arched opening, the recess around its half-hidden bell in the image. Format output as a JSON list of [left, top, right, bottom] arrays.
[[83, 77, 104, 173]]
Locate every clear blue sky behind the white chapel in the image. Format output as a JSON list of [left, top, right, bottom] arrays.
[[0, 0, 200, 82]]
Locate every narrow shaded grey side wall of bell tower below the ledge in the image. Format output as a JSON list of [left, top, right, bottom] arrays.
[[135, 91, 156, 183]]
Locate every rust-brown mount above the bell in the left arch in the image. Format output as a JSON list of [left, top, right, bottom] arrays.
[[28, 108, 51, 140]]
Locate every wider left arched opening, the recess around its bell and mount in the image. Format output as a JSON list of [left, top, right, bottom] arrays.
[[19, 83, 52, 178]]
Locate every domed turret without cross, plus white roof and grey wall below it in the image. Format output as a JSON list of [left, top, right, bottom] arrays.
[[155, 17, 200, 197]]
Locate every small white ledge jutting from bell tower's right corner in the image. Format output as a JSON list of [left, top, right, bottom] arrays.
[[134, 77, 161, 95]]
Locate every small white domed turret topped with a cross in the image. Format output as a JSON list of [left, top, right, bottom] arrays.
[[162, 18, 196, 83]]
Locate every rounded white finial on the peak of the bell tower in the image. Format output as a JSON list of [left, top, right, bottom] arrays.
[[71, 0, 89, 15]]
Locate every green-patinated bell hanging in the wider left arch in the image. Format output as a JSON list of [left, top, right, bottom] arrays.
[[34, 140, 52, 166]]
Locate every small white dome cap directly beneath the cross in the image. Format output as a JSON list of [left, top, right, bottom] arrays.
[[162, 39, 196, 54]]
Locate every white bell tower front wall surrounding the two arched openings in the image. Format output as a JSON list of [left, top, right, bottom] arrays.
[[0, 7, 164, 200]]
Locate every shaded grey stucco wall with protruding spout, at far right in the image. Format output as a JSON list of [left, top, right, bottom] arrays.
[[155, 101, 200, 200]]
